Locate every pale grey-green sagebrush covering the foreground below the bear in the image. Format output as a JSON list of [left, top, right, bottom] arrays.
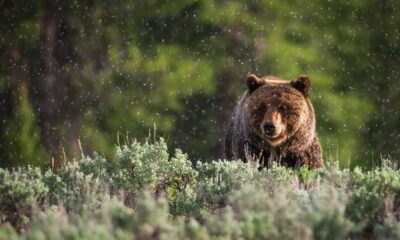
[[0, 139, 400, 239]]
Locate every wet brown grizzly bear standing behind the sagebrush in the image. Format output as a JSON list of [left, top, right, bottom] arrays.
[[225, 74, 323, 168]]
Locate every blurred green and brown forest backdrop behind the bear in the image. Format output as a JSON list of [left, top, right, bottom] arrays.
[[0, 0, 400, 167]]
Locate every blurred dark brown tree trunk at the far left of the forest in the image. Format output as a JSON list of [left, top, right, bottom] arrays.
[[30, 0, 79, 159]]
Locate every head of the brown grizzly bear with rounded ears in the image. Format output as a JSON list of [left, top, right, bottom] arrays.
[[246, 74, 311, 146]]
